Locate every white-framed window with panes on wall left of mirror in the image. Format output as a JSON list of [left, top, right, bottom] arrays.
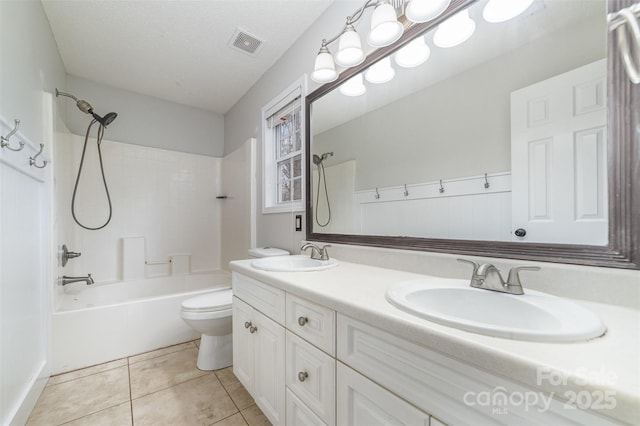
[[262, 77, 305, 213]]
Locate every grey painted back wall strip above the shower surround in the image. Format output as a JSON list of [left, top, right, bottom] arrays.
[[65, 75, 224, 157]]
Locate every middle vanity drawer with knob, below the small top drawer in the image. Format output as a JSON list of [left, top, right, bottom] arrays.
[[285, 330, 336, 425]]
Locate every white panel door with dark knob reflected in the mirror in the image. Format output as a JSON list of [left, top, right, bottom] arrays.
[[511, 59, 608, 245]]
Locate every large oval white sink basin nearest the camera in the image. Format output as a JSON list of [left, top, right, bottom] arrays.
[[386, 278, 606, 342]]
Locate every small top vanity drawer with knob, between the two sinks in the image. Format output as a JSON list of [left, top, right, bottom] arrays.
[[286, 293, 336, 356]]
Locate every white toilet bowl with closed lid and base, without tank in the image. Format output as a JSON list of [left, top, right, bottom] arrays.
[[180, 288, 233, 370]]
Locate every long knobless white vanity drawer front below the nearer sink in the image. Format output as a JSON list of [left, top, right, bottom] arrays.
[[336, 314, 612, 425]]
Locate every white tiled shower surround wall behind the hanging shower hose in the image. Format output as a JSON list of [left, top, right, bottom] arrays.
[[55, 129, 222, 282]]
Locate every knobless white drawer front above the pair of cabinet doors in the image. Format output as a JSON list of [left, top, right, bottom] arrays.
[[231, 272, 285, 325]]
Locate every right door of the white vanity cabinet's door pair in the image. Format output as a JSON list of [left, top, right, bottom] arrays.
[[252, 311, 285, 424]]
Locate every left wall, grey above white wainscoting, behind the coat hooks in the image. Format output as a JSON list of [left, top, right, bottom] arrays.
[[0, 1, 65, 424]]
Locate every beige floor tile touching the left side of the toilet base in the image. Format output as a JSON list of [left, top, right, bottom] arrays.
[[129, 346, 208, 399]]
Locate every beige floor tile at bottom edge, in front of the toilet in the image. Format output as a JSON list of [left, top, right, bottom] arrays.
[[132, 374, 238, 426]]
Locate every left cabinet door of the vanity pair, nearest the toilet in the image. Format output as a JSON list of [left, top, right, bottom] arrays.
[[232, 297, 256, 393]]
